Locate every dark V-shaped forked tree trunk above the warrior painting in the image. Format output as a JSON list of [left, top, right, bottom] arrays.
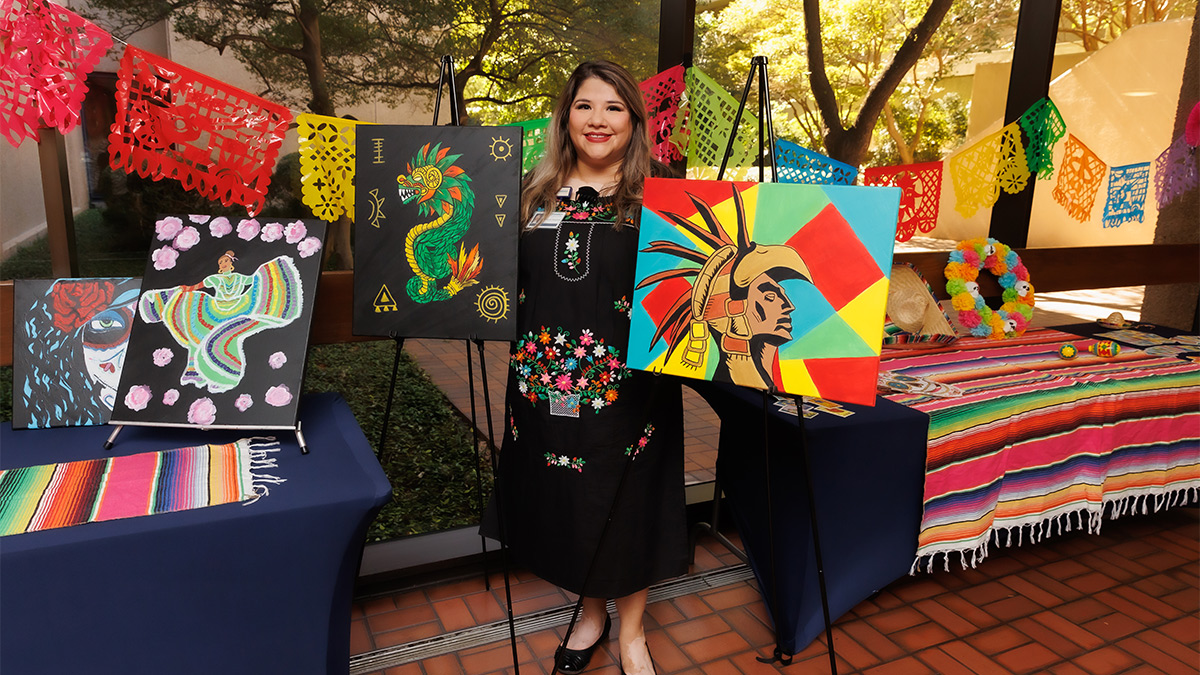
[[804, 0, 953, 167]]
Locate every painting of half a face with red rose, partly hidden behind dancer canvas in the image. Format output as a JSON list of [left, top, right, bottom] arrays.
[[13, 279, 140, 429]]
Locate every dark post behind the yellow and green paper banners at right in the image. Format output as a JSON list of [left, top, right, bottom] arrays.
[[988, 0, 1062, 249]]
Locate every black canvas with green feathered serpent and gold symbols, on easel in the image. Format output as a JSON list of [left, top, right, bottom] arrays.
[[354, 125, 521, 340]]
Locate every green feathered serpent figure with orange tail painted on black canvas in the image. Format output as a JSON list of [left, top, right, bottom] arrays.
[[396, 143, 484, 303]]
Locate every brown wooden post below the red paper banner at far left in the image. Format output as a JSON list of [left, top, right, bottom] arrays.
[[37, 127, 79, 277]]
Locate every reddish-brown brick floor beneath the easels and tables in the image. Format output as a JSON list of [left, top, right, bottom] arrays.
[[350, 507, 1200, 675]]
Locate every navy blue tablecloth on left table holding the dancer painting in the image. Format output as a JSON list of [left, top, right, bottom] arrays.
[[0, 394, 391, 675]]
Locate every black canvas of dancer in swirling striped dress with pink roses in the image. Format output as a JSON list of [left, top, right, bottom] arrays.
[[112, 215, 325, 429]]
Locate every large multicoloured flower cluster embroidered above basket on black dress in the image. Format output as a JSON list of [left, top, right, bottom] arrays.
[[509, 327, 630, 412]]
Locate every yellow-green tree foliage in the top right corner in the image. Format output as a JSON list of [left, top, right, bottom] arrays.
[[1058, 0, 1196, 52]]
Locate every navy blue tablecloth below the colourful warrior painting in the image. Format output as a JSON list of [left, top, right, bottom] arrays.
[[696, 384, 929, 653]]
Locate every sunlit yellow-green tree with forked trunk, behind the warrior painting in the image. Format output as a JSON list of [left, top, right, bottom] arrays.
[[697, 0, 1014, 165]]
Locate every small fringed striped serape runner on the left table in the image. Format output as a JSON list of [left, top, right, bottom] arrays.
[[0, 438, 286, 537]]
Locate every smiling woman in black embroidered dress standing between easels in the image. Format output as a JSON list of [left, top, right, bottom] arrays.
[[487, 61, 686, 675]]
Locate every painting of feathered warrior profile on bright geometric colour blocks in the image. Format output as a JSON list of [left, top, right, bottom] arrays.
[[628, 179, 900, 405]]
